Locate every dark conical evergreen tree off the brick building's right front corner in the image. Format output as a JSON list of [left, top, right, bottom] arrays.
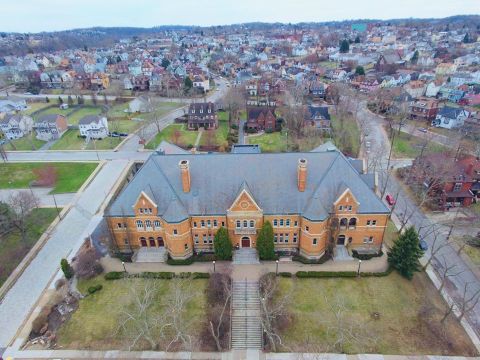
[[388, 226, 423, 280]]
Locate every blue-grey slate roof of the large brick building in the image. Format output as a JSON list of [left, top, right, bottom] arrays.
[[106, 151, 389, 222]]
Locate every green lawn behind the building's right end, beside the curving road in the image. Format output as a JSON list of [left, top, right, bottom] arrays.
[[330, 114, 360, 157]]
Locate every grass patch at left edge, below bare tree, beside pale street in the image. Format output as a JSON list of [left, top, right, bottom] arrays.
[[0, 208, 57, 286]]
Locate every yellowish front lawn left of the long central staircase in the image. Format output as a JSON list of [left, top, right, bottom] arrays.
[[57, 276, 207, 350]]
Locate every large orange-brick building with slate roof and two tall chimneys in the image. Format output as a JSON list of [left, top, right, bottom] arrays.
[[106, 148, 389, 259]]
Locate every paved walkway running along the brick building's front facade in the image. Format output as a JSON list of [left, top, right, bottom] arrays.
[[101, 255, 388, 280]]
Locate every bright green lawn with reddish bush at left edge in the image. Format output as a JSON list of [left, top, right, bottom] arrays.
[[0, 163, 98, 193]]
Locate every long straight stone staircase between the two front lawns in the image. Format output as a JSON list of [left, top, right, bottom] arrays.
[[231, 280, 263, 350]]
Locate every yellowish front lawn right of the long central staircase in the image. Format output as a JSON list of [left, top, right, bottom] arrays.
[[279, 272, 475, 356]]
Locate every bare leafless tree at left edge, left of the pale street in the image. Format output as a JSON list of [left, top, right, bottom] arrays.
[[7, 191, 39, 245]]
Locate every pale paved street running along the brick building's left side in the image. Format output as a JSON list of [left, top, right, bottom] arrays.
[[0, 160, 129, 348]]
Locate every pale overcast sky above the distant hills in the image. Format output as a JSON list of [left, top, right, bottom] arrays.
[[0, 0, 480, 32]]
